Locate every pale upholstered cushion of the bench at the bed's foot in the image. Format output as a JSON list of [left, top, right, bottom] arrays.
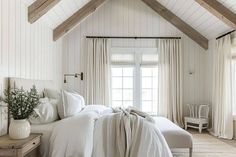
[[154, 117, 193, 148]]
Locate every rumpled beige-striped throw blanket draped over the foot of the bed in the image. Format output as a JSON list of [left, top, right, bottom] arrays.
[[93, 108, 172, 157]]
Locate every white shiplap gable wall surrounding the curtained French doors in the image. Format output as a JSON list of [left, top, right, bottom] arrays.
[[63, 0, 208, 112]]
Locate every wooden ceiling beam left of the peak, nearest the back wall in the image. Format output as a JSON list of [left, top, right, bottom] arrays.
[[53, 0, 106, 41]]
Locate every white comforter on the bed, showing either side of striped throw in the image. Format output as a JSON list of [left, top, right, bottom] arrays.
[[49, 106, 172, 157]]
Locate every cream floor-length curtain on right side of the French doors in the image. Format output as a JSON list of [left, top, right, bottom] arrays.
[[157, 39, 183, 126]]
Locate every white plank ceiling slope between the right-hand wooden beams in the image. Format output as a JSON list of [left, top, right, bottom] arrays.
[[158, 0, 236, 39]]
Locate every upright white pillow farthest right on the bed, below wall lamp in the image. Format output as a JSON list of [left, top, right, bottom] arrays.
[[58, 90, 85, 118]]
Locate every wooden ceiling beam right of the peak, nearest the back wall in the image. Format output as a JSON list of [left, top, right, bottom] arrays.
[[142, 0, 208, 49]]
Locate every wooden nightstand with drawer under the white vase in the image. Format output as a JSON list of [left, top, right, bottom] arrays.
[[0, 134, 41, 157]]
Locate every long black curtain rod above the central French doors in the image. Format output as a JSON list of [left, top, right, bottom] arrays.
[[86, 36, 181, 39]]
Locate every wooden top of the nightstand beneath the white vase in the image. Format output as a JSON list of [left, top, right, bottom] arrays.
[[0, 134, 42, 149]]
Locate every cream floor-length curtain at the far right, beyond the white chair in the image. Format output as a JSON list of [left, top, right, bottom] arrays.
[[212, 35, 233, 139]]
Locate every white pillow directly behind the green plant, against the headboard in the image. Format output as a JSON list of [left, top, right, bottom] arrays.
[[29, 97, 58, 124]]
